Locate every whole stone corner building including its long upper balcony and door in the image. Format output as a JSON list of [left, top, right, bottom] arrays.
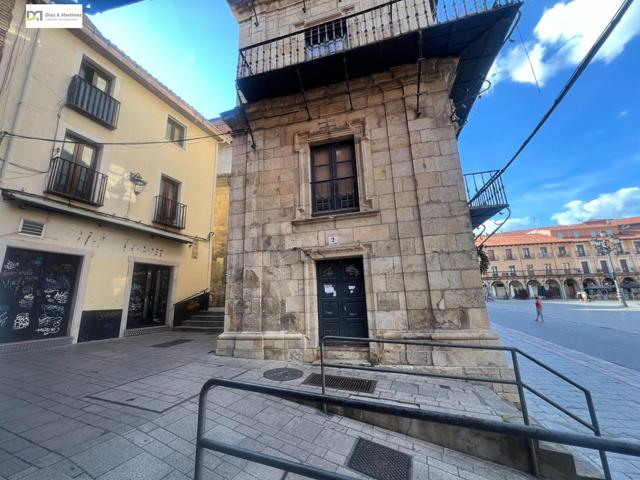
[[217, 0, 520, 367]]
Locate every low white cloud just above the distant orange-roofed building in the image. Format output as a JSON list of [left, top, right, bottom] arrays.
[[551, 187, 640, 225]]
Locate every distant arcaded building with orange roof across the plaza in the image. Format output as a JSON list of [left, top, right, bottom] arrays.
[[477, 217, 640, 299]]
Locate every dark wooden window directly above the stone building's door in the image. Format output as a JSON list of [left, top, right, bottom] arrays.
[[311, 140, 358, 215]]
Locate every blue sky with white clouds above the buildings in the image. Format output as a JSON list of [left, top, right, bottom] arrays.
[[91, 0, 640, 229]]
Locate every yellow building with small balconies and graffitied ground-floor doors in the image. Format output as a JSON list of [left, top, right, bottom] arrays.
[[0, 1, 223, 350]]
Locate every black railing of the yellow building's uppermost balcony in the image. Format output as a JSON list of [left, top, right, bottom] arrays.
[[67, 75, 120, 129]]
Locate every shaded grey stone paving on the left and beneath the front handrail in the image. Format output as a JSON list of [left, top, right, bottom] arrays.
[[0, 332, 530, 480]]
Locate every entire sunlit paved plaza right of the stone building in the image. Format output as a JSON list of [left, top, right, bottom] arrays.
[[489, 300, 640, 480]]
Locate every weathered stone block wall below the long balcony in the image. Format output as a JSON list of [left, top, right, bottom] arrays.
[[218, 59, 504, 376]]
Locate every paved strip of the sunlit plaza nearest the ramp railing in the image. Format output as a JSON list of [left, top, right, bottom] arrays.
[[494, 324, 640, 480]]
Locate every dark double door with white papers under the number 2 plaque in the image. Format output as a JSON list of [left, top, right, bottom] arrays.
[[316, 258, 369, 338]]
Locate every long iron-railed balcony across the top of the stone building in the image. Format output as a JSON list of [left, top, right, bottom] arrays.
[[232, 0, 521, 127]]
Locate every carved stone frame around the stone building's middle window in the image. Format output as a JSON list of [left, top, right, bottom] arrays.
[[293, 118, 377, 221]]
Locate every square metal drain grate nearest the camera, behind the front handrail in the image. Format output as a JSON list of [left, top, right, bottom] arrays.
[[348, 438, 412, 480]]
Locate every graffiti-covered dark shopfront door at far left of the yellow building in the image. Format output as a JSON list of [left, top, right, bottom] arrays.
[[0, 248, 80, 343]]
